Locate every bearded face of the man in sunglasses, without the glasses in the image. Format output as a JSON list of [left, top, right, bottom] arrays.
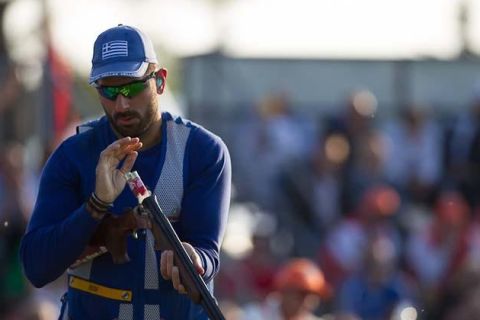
[[98, 77, 161, 138]]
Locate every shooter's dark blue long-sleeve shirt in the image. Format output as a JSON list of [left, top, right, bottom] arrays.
[[20, 113, 231, 319]]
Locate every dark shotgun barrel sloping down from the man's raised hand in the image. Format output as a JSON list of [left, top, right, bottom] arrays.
[[125, 171, 225, 320]]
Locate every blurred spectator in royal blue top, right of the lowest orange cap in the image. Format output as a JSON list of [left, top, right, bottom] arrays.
[[337, 236, 413, 320]]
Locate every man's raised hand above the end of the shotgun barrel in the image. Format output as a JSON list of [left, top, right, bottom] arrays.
[[95, 137, 142, 203]]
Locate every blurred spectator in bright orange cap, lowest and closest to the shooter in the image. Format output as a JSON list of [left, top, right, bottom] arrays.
[[244, 258, 331, 320]]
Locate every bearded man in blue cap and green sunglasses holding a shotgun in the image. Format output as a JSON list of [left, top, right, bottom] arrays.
[[20, 25, 231, 320]]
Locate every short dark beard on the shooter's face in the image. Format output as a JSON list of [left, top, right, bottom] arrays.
[[105, 99, 158, 138]]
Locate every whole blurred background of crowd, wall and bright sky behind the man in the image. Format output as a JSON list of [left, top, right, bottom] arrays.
[[0, 0, 480, 320]]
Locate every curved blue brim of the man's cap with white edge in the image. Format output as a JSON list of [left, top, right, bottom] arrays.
[[88, 62, 148, 84]]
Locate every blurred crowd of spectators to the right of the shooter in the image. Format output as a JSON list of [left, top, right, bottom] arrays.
[[217, 90, 480, 320]]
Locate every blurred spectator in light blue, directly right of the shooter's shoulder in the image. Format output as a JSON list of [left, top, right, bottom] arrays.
[[233, 93, 311, 211]]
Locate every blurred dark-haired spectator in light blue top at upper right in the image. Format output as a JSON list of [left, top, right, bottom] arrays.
[[385, 105, 443, 202]]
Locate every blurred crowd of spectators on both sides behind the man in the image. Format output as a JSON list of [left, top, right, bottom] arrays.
[[0, 50, 480, 320]]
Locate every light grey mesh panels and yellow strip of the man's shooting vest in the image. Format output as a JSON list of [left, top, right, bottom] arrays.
[[66, 118, 191, 320]]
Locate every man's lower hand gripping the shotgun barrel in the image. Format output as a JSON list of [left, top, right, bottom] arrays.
[[160, 242, 205, 294]]
